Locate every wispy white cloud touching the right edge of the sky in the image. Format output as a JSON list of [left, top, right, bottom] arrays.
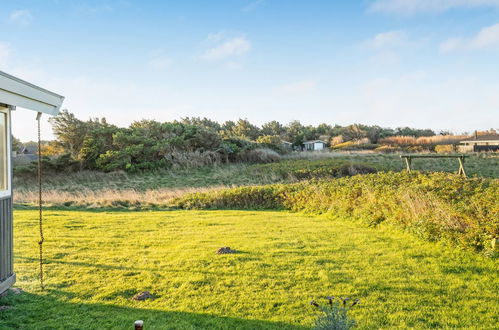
[[440, 23, 499, 53]]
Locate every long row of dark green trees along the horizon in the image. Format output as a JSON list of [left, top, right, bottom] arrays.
[[31, 110, 435, 171]]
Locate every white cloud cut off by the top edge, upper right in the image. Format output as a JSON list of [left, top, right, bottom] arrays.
[[369, 0, 499, 15]]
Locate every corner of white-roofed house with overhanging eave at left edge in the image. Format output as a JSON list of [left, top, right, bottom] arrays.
[[0, 71, 64, 294]]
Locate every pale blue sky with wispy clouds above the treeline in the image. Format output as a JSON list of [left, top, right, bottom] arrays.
[[0, 0, 499, 140]]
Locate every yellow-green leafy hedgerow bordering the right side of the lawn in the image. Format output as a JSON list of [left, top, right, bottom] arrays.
[[172, 172, 499, 250]]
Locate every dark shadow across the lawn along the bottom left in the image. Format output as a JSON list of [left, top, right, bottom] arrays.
[[0, 291, 306, 329]]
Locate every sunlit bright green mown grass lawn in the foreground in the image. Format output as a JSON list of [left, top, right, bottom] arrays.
[[0, 211, 499, 329]]
